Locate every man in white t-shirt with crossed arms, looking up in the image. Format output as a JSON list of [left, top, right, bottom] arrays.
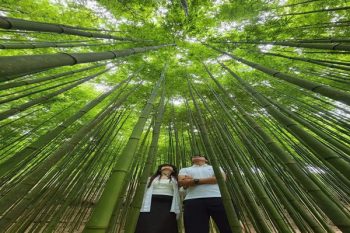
[[178, 155, 231, 233]]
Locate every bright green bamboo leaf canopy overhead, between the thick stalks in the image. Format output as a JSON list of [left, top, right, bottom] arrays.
[[0, 0, 350, 232]]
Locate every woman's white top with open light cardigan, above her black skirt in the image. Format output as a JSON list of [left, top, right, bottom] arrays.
[[140, 176, 181, 217]]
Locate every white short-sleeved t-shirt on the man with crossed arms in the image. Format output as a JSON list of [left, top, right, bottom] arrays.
[[179, 164, 223, 200]]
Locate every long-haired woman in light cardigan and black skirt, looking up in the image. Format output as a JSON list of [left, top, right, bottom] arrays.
[[135, 164, 181, 233]]
